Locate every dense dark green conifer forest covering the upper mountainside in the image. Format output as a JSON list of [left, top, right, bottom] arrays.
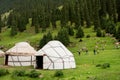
[[0, 0, 120, 43]]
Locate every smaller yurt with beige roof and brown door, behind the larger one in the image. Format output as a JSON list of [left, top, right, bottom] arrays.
[[5, 42, 36, 66]]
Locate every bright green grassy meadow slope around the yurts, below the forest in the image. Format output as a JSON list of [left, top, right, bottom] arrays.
[[0, 24, 120, 80]]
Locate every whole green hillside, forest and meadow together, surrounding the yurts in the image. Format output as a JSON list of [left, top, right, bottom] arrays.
[[0, 0, 120, 80]]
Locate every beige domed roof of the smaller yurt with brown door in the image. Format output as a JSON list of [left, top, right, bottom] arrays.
[[6, 42, 36, 56]]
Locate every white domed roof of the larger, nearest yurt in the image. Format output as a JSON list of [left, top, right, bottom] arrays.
[[35, 40, 73, 58]]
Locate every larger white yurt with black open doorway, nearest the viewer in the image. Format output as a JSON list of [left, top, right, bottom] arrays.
[[34, 40, 76, 69]]
